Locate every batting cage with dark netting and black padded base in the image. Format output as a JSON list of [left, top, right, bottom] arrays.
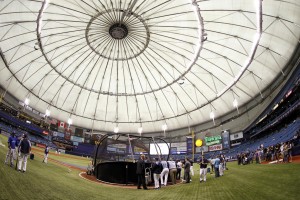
[[93, 134, 170, 185]]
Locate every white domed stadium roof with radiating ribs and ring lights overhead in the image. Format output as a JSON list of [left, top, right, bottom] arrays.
[[0, 0, 300, 133]]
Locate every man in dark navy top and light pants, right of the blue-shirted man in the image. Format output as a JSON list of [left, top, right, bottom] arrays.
[[18, 134, 31, 173]]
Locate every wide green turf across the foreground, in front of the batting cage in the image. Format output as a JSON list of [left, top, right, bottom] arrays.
[[0, 135, 300, 200]]
